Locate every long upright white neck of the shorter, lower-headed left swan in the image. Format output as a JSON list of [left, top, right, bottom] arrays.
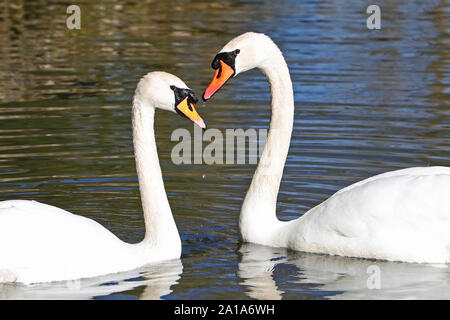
[[132, 94, 181, 251]]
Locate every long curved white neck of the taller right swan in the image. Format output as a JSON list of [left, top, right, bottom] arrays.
[[240, 40, 294, 243]]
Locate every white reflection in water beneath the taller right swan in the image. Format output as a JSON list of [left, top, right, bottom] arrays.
[[237, 243, 450, 300]]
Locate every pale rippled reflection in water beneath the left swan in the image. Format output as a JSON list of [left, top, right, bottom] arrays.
[[0, 259, 183, 300]]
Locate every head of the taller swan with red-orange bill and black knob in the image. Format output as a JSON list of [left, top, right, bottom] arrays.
[[203, 32, 277, 101]]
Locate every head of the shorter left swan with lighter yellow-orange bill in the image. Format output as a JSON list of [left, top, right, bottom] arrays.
[[135, 71, 206, 129]]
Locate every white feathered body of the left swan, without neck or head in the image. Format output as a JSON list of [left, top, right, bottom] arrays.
[[0, 200, 143, 283]]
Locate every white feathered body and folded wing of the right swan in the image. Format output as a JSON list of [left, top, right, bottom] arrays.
[[291, 167, 450, 263]]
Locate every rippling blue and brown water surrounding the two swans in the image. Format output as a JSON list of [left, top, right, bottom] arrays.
[[0, 0, 450, 299]]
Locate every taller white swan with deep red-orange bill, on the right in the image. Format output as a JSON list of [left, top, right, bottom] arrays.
[[203, 33, 450, 263]]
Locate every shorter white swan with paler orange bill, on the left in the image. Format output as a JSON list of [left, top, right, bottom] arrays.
[[0, 72, 205, 284]]
